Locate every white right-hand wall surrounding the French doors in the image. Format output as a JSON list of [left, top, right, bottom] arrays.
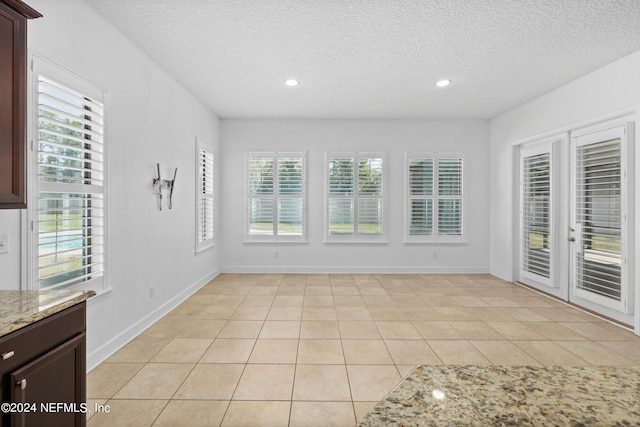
[[491, 51, 640, 330]]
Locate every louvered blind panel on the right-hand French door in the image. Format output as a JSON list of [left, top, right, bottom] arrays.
[[576, 139, 622, 301]]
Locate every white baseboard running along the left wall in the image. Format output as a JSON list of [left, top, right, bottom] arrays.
[[87, 268, 220, 372]]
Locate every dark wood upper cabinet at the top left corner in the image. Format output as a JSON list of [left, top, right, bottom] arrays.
[[0, 0, 42, 209]]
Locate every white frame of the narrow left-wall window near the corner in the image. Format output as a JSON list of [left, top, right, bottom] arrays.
[[195, 138, 216, 253]]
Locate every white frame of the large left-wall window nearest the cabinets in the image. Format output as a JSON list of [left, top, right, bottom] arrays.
[[22, 53, 109, 294]]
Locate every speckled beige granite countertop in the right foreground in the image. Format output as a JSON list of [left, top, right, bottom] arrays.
[[359, 366, 640, 427]]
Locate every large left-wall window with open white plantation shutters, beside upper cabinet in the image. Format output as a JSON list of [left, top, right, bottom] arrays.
[[31, 62, 106, 289]]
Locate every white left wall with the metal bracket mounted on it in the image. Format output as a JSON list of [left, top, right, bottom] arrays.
[[0, 0, 220, 368]]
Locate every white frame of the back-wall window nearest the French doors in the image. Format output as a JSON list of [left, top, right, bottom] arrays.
[[404, 151, 467, 245]]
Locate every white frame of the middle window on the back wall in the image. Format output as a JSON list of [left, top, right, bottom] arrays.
[[324, 151, 388, 245]]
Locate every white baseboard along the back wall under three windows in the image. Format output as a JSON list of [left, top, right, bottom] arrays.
[[221, 265, 489, 274]]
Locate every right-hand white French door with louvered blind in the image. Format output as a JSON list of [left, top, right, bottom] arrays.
[[569, 126, 629, 313]]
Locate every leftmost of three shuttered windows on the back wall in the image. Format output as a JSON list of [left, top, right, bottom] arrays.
[[246, 152, 306, 242]]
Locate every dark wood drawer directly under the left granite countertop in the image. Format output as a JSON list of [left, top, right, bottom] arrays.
[[0, 303, 86, 372]]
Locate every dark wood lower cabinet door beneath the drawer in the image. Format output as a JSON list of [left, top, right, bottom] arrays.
[[10, 333, 86, 427]]
